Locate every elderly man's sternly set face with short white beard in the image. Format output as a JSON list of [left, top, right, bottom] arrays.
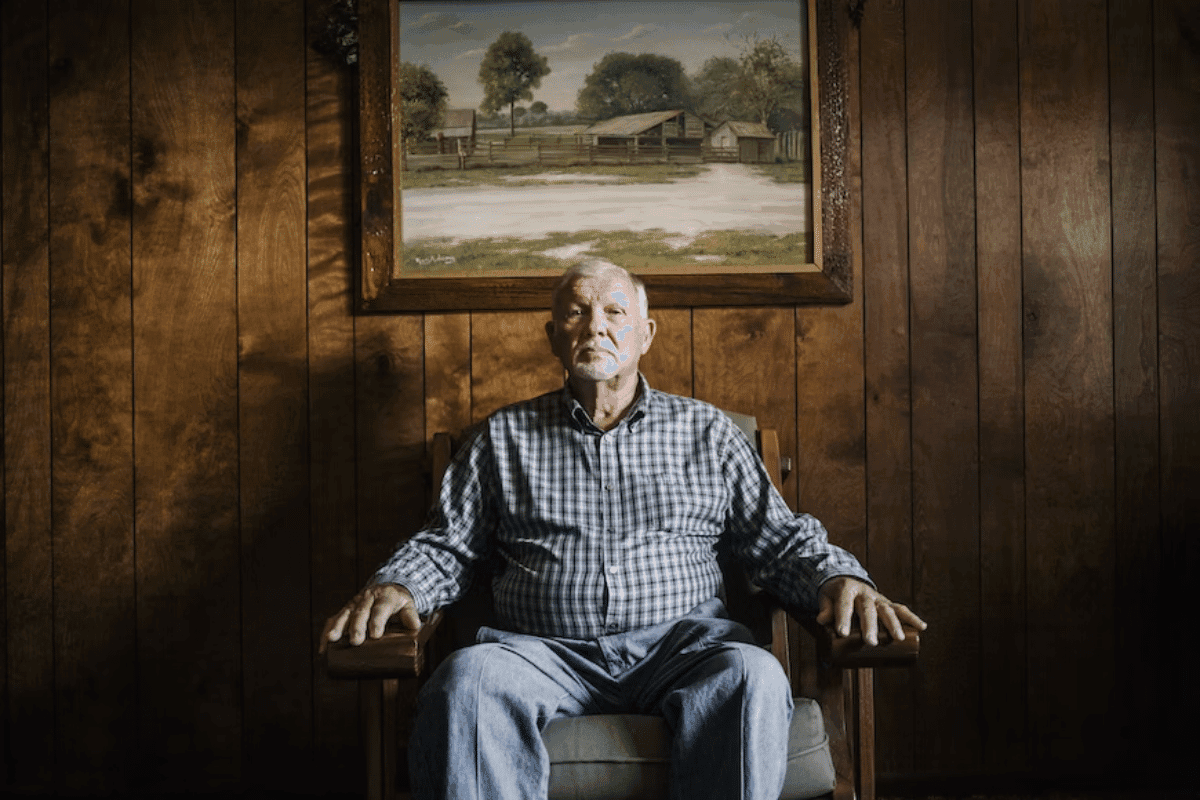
[[546, 272, 654, 381]]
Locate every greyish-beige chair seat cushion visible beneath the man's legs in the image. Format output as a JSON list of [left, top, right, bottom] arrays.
[[542, 697, 834, 800]]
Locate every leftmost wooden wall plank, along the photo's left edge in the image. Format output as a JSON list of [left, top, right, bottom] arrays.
[[0, 2, 54, 792]]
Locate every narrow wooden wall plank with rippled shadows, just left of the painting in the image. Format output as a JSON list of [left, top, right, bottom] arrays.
[[306, 0, 364, 793]]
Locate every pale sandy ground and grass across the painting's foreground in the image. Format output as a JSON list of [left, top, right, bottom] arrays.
[[401, 163, 812, 277]]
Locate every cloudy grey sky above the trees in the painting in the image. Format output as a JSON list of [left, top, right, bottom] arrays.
[[400, 0, 802, 112]]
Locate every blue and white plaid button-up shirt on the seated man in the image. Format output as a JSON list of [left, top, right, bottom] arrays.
[[372, 378, 869, 639]]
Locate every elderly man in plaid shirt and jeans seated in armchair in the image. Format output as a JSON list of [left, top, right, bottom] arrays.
[[324, 264, 925, 800]]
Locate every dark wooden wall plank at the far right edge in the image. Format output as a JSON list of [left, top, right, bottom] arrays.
[[1152, 0, 1200, 780]]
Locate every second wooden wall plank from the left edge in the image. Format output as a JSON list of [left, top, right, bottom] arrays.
[[48, 2, 137, 793]]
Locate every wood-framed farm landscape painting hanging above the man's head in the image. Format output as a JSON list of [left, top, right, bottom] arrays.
[[358, 0, 852, 313]]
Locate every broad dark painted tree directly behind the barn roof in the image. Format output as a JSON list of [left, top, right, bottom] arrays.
[[575, 53, 691, 120]]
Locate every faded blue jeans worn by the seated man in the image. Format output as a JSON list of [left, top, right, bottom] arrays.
[[409, 600, 792, 800]]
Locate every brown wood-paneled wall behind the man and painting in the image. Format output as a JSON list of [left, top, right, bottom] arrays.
[[0, 0, 1200, 793]]
